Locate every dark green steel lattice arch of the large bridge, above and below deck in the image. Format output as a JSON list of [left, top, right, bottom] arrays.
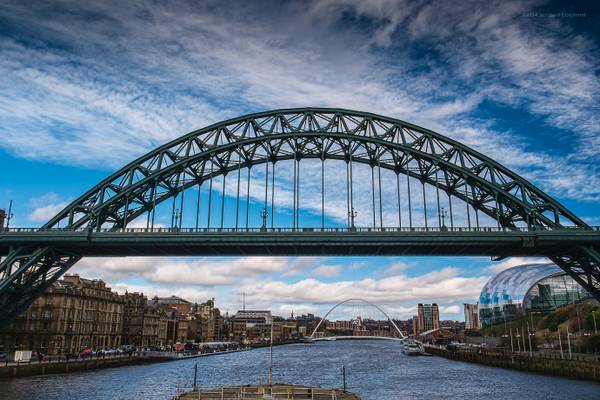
[[0, 108, 600, 324]]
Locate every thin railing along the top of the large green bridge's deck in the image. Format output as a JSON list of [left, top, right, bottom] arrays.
[[0, 226, 600, 234]]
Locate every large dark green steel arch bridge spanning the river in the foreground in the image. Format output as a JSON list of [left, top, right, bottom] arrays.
[[0, 108, 600, 326]]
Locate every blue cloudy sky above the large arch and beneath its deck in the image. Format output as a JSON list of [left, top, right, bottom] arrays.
[[0, 0, 600, 320]]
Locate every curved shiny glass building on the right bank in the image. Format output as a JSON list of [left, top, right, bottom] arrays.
[[478, 263, 591, 326]]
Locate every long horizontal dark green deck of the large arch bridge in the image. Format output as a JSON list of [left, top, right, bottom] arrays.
[[0, 228, 600, 257]]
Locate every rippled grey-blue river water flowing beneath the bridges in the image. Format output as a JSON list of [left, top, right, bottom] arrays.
[[0, 340, 600, 400]]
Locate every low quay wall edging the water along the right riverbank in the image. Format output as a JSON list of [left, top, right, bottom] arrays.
[[425, 346, 600, 383]]
